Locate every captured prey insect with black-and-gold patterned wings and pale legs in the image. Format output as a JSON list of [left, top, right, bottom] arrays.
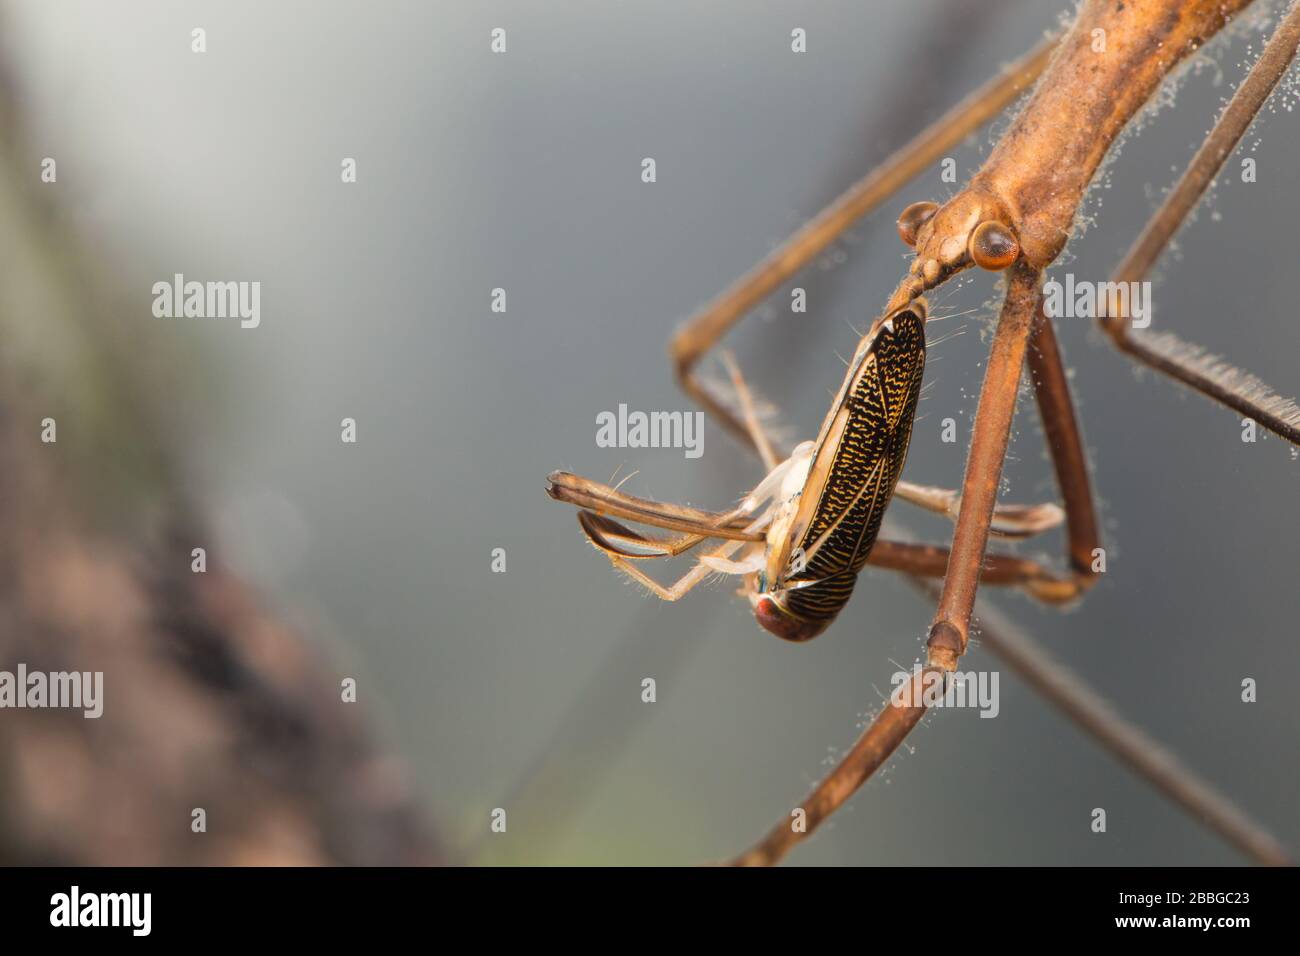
[[547, 298, 1073, 641]]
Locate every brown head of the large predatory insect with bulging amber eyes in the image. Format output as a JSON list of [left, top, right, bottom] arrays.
[[898, 187, 1021, 295]]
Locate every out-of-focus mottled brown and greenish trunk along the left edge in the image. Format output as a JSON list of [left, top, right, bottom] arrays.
[[0, 35, 442, 865]]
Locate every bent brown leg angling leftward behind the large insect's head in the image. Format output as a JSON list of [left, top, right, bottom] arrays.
[[668, 40, 1056, 444]]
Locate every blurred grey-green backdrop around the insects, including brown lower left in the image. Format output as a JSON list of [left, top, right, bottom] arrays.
[[0, 0, 1300, 865]]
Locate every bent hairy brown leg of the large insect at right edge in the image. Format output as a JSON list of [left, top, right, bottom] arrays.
[[1101, 4, 1300, 444]]
